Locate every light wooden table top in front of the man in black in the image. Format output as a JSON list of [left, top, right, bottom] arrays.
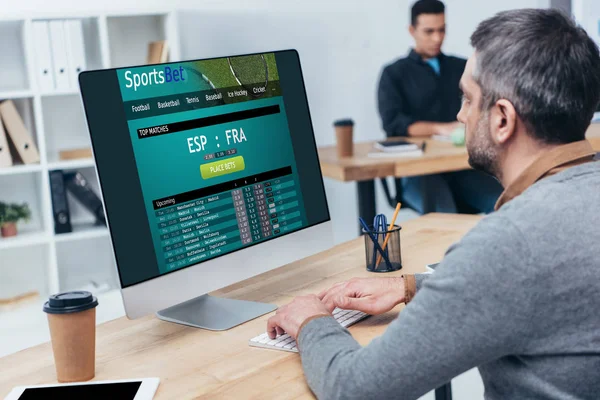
[[319, 123, 600, 182]]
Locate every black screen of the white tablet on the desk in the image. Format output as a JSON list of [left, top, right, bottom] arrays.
[[19, 381, 142, 400]]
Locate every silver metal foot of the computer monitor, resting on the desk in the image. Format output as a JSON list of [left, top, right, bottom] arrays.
[[156, 294, 277, 331]]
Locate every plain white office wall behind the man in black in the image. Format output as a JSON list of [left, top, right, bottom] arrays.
[[1, 0, 549, 242]]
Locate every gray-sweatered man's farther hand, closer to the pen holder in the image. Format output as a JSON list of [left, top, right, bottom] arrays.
[[318, 277, 404, 315]]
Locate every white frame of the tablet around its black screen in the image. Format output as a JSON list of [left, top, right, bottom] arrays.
[[5, 378, 159, 400]]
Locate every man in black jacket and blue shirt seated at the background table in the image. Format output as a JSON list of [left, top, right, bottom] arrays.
[[378, 0, 502, 213]]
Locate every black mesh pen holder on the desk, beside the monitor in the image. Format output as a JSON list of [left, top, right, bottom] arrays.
[[362, 225, 402, 272]]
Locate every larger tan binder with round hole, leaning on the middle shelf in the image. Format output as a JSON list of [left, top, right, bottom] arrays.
[[0, 100, 40, 164]]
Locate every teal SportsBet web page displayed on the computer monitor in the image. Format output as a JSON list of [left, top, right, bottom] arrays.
[[117, 54, 307, 273]]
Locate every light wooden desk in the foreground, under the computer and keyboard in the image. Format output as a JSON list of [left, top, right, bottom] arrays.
[[0, 214, 479, 400]]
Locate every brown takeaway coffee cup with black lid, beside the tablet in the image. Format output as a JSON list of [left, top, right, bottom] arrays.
[[44, 291, 98, 382]]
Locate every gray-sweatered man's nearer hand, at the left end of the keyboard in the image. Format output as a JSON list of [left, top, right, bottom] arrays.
[[267, 294, 331, 339]]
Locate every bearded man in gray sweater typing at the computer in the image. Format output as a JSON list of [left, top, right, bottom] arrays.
[[267, 10, 600, 399]]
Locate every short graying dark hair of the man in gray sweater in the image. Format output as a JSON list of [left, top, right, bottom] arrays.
[[471, 9, 600, 144]]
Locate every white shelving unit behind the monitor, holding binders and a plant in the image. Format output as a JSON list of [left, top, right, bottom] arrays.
[[0, 10, 180, 304]]
